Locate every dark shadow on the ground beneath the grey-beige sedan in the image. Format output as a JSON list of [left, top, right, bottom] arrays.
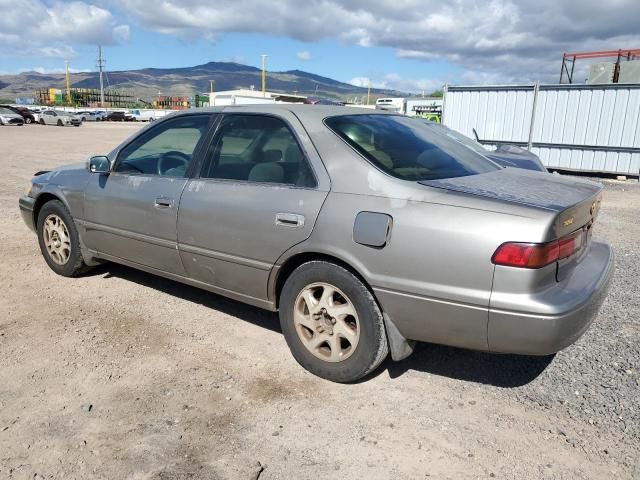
[[87, 263, 554, 388]]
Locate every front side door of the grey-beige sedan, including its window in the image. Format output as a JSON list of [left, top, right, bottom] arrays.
[[84, 114, 211, 275]]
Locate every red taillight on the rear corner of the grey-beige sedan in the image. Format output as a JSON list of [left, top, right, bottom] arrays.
[[491, 230, 584, 268]]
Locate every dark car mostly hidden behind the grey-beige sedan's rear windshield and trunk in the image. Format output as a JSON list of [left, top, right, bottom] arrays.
[[422, 120, 548, 172]]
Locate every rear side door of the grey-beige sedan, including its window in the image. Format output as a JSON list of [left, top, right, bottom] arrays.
[[178, 112, 329, 303]]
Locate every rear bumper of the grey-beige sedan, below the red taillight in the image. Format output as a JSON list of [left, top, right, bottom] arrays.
[[487, 242, 615, 355]]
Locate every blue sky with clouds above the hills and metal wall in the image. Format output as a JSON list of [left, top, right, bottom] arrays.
[[0, 0, 640, 92]]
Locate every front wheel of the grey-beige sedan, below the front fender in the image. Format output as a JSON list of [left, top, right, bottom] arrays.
[[37, 200, 89, 277]]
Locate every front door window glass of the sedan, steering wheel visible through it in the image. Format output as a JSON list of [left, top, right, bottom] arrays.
[[114, 115, 210, 177]]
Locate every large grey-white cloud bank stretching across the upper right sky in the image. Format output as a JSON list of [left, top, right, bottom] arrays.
[[120, 0, 640, 83]]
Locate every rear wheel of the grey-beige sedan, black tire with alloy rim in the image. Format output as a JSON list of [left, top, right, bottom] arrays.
[[280, 261, 389, 383]]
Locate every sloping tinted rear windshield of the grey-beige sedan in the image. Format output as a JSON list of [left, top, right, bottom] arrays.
[[325, 115, 500, 181]]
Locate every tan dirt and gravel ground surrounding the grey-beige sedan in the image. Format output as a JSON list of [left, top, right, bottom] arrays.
[[0, 124, 640, 480]]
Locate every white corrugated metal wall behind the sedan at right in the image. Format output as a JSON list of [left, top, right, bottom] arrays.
[[443, 84, 640, 175]]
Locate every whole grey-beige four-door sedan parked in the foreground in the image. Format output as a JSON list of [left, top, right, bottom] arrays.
[[19, 105, 614, 382]]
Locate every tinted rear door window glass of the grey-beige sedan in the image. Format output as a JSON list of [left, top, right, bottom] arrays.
[[201, 115, 316, 187]]
